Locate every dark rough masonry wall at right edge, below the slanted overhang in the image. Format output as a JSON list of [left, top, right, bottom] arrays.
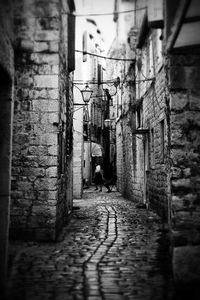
[[168, 53, 200, 282]]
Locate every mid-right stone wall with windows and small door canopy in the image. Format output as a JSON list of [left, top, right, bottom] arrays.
[[135, 29, 170, 221]]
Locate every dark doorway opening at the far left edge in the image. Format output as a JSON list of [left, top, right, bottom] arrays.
[[0, 68, 13, 288]]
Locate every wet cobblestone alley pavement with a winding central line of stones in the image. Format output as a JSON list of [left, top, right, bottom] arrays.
[[8, 188, 173, 300]]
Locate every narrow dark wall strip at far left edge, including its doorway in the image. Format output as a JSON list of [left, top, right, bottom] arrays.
[[0, 1, 14, 290]]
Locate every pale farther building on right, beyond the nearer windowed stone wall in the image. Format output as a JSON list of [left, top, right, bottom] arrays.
[[107, 1, 139, 199]]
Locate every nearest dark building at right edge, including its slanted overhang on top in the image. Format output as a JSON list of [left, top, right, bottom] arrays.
[[165, 1, 200, 287]]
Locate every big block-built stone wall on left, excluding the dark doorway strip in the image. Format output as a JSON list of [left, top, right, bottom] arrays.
[[10, 0, 72, 240]]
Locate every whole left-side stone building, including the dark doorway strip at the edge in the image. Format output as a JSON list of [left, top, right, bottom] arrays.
[[0, 0, 75, 293]]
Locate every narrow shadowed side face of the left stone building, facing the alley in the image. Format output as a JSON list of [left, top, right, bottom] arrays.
[[56, 0, 73, 233]]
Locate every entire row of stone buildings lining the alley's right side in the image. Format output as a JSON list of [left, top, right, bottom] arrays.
[[112, 0, 200, 287]]
